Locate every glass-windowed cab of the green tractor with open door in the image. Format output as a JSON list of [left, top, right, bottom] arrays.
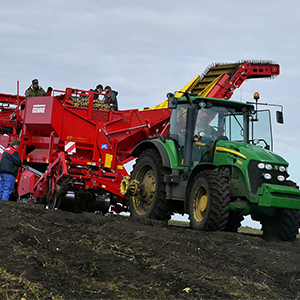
[[169, 97, 273, 165]]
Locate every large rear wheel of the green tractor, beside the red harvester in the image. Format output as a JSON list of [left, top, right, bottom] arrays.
[[129, 149, 172, 221]]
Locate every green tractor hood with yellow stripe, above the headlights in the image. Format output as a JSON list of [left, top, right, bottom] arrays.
[[216, 141, 288, 165]]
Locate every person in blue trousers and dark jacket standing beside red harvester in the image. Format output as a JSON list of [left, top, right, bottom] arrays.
[[0, 140, 22, 201]]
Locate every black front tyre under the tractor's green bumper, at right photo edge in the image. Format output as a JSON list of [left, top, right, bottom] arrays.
[[260, 180, 300, 242]]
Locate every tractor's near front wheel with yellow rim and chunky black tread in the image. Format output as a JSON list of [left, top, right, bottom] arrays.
[[187, 170, 230, 231]]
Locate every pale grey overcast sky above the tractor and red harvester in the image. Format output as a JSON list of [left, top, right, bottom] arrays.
[[0, 0, 300, 226]]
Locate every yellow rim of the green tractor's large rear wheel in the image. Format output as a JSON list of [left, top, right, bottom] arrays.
[[132, 165, 156, 216]]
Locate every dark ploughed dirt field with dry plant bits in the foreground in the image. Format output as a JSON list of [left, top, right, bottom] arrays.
[[0, 201, 300, 299]]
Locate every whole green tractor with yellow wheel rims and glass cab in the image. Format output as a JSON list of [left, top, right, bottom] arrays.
[[122, 94, 300, 241]]
